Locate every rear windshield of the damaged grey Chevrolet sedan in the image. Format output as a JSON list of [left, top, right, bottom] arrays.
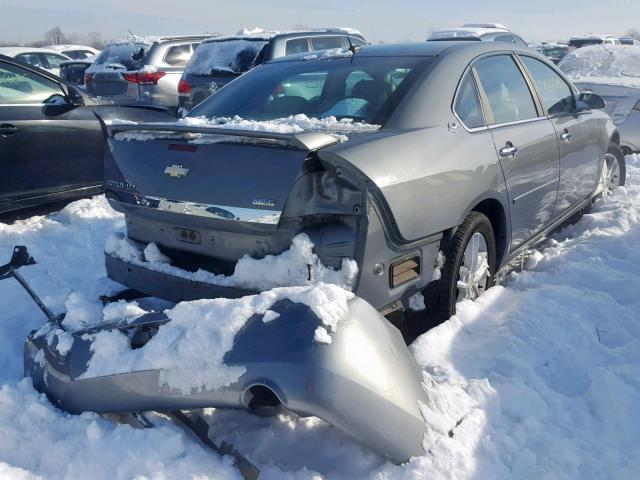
[[188, 55, 431, 125]]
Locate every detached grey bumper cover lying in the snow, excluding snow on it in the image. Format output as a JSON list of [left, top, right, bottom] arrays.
[[24, 297, 427, 463]]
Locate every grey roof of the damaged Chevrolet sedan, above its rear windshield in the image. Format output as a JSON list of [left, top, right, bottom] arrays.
[[267, 40, 535, 63]]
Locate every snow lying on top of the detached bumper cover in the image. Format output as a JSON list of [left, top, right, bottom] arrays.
[[80, 284, 353, 394]]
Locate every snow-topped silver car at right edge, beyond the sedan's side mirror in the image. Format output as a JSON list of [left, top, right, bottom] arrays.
[[559, 45, 640, 158]]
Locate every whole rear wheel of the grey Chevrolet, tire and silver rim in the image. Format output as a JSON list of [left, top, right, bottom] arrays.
[[436, 212, 496, 321]]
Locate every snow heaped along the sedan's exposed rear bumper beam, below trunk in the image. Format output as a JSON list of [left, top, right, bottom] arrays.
[[105, 233, 358, 291]]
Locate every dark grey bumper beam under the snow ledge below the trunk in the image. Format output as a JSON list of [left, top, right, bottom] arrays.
[[104, 249, 256, 303]]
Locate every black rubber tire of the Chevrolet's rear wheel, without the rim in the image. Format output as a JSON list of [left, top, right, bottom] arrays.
[[434, 212, 496, 322]]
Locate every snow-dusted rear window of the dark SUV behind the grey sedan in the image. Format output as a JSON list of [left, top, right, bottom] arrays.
[[185, 39, 269, 75]]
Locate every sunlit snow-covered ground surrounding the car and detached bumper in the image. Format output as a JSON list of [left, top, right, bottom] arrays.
[[0, 156, 640, 480]]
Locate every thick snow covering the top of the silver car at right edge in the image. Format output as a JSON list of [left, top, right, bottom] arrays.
[[558, 45, 640, 87]]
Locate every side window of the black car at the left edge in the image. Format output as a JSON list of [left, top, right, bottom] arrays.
[[0, 63, 62, 105]]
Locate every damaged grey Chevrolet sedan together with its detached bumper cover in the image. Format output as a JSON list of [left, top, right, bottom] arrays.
[[25, 42, 624, 462]]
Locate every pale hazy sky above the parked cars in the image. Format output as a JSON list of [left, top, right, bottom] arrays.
[[0, 0, 640, 42]]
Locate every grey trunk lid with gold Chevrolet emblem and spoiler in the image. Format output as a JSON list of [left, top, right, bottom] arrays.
[[105, 125, 337, 228]]
